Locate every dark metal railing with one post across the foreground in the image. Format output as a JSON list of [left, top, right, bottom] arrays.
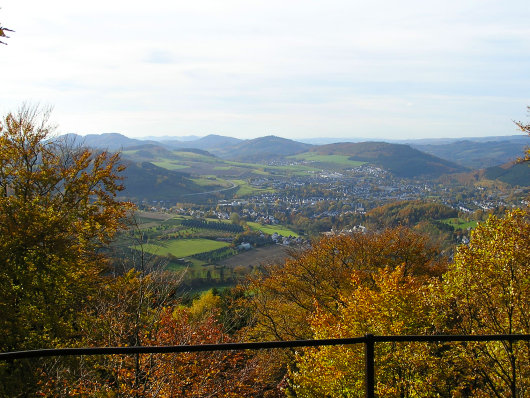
[[0, 334, 530, 398]]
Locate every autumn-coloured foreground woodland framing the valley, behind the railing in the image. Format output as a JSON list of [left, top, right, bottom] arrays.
[[0, 107, 530, 397]]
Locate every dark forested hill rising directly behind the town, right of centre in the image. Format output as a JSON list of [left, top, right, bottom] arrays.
[[311, 142, 466, 178]]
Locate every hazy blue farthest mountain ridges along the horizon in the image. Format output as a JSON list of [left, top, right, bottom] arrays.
[[66, 133, 530, 168]]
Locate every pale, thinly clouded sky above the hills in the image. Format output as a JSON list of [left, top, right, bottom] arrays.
[[0, 0, 530, 139]]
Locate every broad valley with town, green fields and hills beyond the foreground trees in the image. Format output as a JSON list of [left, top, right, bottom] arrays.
[[84, 132, 530, 290]]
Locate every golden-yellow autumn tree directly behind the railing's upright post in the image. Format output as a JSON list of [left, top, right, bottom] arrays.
[[290, 266, 450, 397]]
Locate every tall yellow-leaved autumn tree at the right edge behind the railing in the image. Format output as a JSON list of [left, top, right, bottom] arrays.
[[444, 210, 530, 397]]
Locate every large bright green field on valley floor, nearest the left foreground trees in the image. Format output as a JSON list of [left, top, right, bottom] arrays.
[[133, 239, 230, 258]]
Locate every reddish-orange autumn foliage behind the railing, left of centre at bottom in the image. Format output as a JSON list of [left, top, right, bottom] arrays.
[[38, 282, 274, 398]]
